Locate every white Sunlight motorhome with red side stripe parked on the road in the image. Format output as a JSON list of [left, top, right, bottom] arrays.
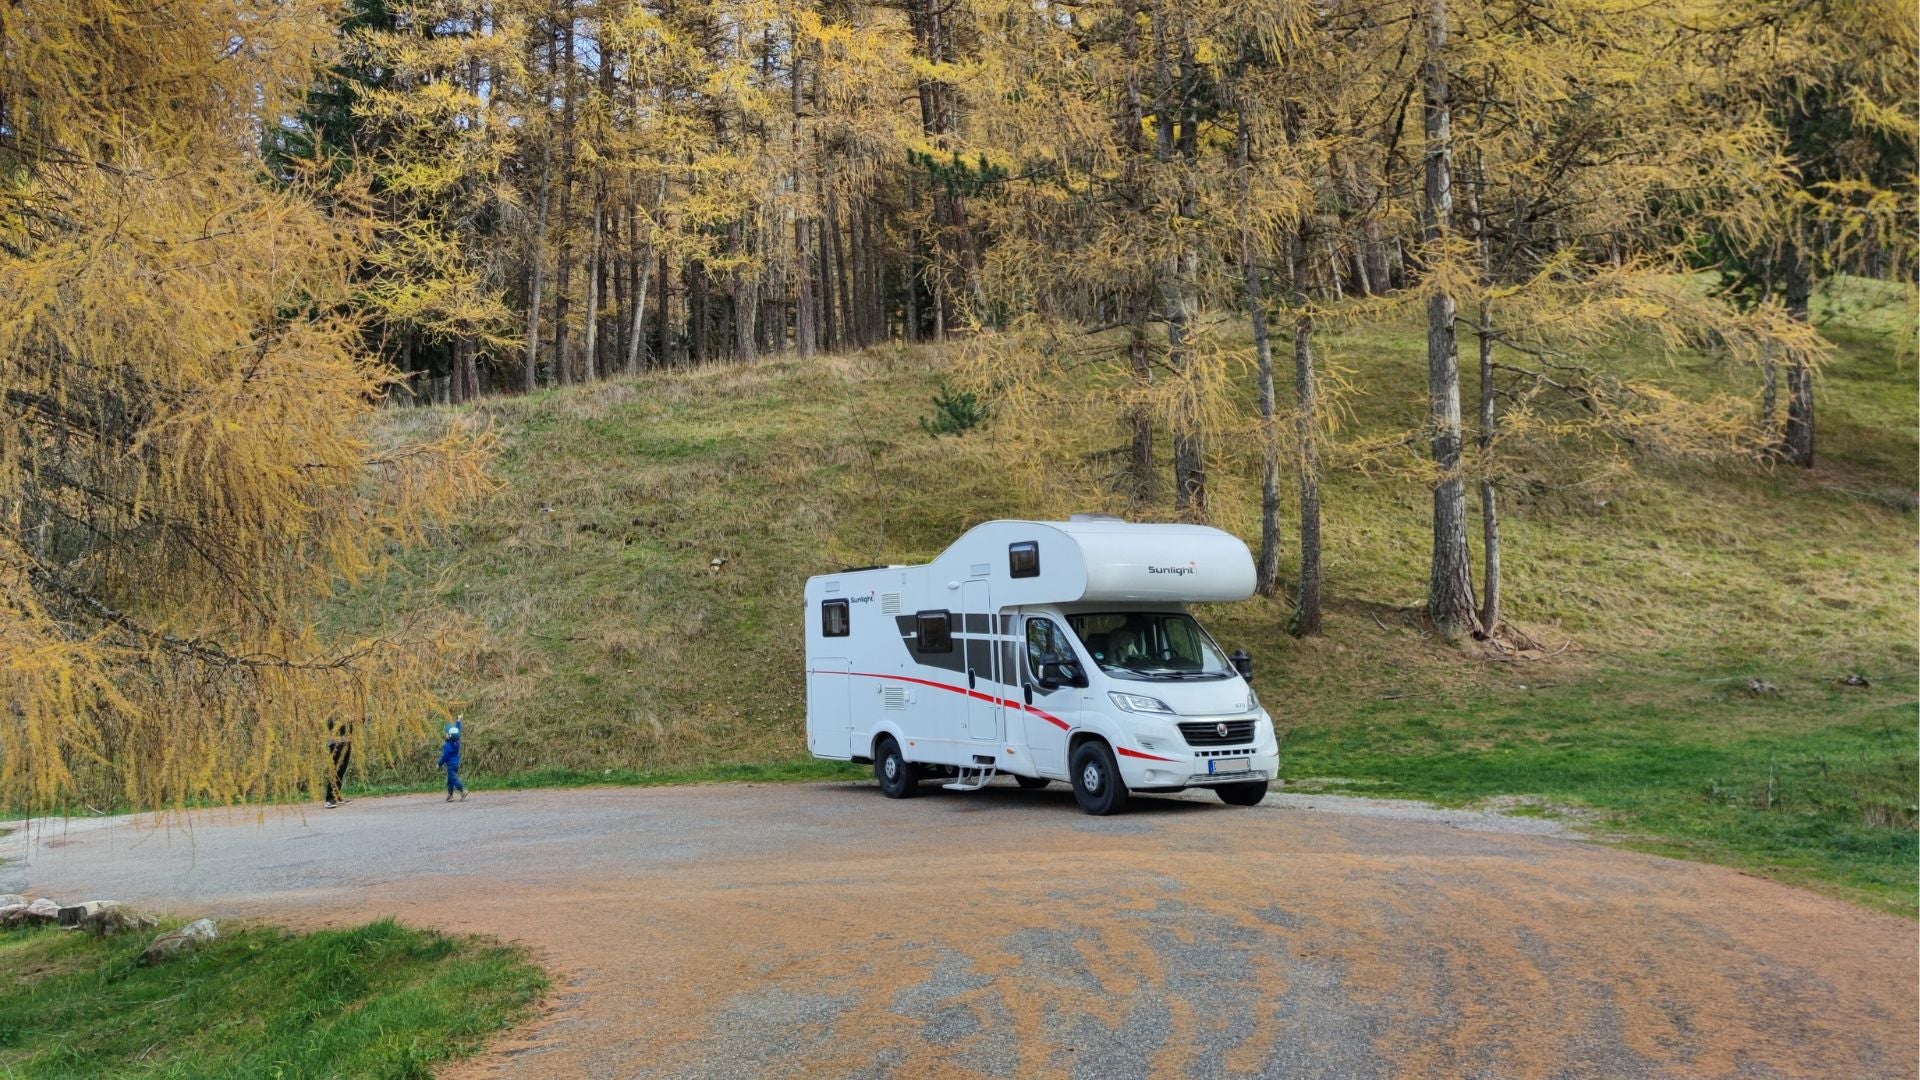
[[806, 515, 1281, 815]]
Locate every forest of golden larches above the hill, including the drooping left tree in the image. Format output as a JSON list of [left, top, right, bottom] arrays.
[[0, 0, 1920, 809]]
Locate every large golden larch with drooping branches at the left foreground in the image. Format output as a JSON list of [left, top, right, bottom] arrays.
[[0, 2, 484, 811]]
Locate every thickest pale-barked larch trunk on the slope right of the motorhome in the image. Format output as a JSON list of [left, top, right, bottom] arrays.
[[1423, 0, 1480, 638]]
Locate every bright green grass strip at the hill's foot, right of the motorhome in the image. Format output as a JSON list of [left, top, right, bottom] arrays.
[[1284, 673, 1920, 917]]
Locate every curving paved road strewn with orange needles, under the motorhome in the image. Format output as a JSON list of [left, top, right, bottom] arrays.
[[0, 784, 1920, 1080]]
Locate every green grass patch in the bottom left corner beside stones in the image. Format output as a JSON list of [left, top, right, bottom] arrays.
[[0, 920, 545, 1080]]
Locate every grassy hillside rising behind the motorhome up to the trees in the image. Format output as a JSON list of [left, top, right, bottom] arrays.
[[330, 274, 1920, 911]]
